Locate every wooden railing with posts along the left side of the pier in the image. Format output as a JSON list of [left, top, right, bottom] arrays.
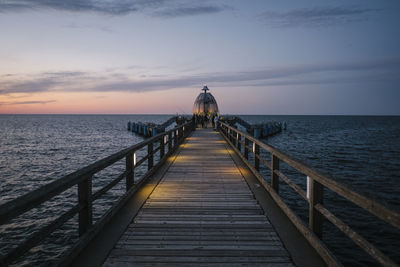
[[0, 122, 192, 266]]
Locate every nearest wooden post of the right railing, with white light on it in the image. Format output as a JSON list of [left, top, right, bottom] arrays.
[[308, 177, 324, 239]]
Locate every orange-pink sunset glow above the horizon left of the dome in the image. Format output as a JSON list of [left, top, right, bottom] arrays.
[[0, 89, 197, 114]]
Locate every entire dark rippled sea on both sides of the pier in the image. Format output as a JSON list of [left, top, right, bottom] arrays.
[[0, 115, 400, 266]]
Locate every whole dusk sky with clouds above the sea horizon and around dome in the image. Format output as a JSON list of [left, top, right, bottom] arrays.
[[0, 0, 400, 115]]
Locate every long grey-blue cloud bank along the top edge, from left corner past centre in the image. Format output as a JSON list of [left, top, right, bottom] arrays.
[[0, 0, 228, 17]]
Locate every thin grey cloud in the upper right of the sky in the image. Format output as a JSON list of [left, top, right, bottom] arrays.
[[258, 6, 379, 27]]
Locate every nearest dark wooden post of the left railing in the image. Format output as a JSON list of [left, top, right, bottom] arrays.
[[78, 175, 93, 236]]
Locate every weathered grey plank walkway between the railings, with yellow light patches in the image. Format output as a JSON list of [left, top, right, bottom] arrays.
[[104, 129, 293, 266]]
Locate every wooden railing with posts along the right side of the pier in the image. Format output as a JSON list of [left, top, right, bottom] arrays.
[[220, 122, 400, 266]]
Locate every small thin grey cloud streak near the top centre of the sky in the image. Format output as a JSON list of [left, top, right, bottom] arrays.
[[153, 5, 230, 18]]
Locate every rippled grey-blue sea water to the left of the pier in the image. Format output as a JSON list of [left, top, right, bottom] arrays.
[[0, 115, 171, 266]]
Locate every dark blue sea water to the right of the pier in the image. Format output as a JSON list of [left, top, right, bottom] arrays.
[[241, 116, 400, 266]]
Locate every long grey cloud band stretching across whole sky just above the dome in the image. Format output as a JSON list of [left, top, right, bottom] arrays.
[[0, 58, 400, 95]]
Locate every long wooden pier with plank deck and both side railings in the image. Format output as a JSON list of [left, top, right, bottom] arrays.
[[0, 122, 400, 266]]
